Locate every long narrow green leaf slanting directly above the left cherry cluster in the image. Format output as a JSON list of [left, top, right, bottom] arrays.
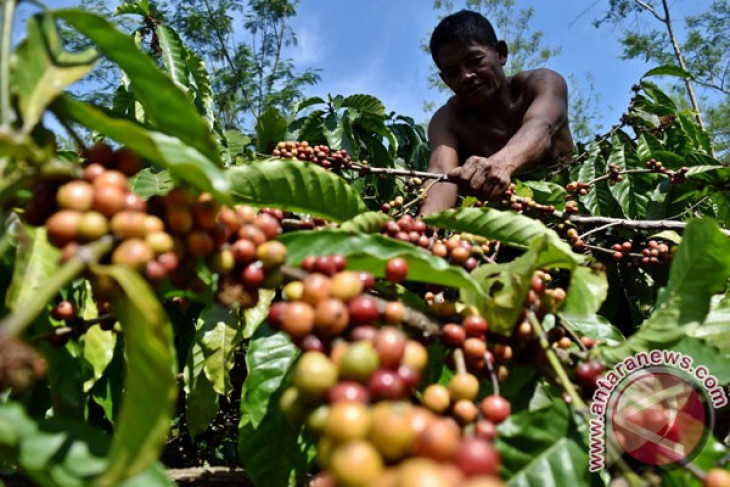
[[54, 96, 230, 201]]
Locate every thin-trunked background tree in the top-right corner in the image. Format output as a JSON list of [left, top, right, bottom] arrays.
[[594, 0, 730, 162]]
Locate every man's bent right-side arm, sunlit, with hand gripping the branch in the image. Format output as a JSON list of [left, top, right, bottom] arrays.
[[449, 69, 568, 200]]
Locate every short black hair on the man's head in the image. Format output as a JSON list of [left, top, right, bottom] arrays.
[[429, 10, 497, 66]]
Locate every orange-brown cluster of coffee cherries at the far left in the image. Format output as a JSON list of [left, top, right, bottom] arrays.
[[24, 144, 287, 307]]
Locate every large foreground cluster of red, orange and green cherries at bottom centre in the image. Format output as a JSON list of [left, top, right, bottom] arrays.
[[269, 255, 501, 487]]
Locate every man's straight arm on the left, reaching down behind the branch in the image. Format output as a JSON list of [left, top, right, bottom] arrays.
[[419, 107, 459, 215]]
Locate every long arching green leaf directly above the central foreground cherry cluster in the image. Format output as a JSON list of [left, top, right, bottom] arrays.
[[279, 229, 483, 294]]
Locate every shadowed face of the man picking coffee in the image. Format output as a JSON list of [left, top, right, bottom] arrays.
[[438, 43, 507, 105]]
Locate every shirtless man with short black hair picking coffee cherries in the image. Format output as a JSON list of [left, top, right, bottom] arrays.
[[421, 10, 573, 215]]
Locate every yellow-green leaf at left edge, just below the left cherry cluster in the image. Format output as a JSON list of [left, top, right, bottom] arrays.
[[5, 224, 60, 310]]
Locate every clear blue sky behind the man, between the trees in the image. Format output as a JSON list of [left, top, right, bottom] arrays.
[[16, 0, 710, 133]]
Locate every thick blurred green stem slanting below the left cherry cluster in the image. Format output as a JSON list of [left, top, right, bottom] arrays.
[[0, 236, 114, 336]]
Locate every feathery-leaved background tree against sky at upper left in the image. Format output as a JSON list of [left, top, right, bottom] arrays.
[[59, 0, 319, 130]]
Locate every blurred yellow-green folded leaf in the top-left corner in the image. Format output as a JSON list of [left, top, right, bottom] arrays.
[[12, 15, 97, 133]]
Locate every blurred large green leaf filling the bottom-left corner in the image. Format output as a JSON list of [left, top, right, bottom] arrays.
[[0, 402, 171, 487]]
